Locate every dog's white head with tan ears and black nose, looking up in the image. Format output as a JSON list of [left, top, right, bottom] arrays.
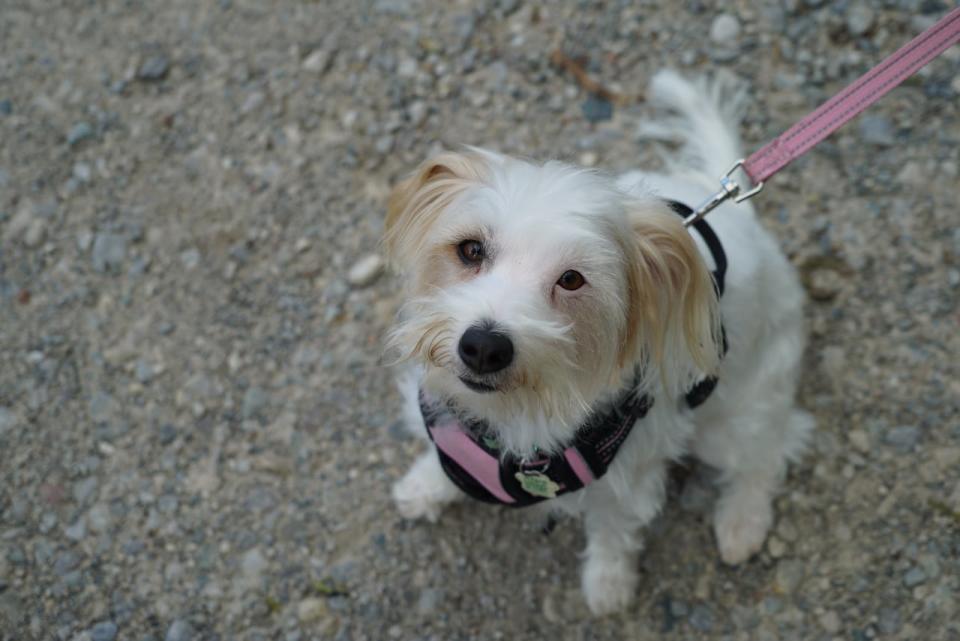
[[384, 150, 717, 448]]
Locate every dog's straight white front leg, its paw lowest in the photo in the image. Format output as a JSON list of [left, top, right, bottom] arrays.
[[582, 466, 664, 615]]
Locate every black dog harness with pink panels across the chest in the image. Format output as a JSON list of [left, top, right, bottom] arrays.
[[420, 201, 727, 507]]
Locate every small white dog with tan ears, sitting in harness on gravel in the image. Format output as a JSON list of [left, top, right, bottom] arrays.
[[385, 72, 813, 614]]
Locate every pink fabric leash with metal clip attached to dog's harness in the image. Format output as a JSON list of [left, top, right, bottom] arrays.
[[684, 7, 960, 227]]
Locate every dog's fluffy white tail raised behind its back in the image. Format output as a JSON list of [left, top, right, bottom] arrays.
[[640, 70, 747, 187]]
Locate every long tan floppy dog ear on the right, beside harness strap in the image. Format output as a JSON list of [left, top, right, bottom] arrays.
[[621, 201, 722, 391]]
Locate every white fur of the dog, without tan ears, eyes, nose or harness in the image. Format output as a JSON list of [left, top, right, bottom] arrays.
[[386, 72, 813, 614]]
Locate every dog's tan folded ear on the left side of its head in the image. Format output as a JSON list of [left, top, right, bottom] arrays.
[[383, 151, 487, 271]]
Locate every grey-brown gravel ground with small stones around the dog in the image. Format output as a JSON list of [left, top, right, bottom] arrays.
[[0, 0, 960, 641]]
